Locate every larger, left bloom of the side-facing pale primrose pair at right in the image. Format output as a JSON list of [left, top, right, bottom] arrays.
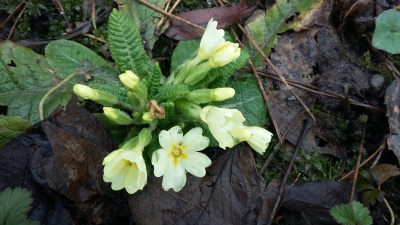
[[200, 106, 252, 149]]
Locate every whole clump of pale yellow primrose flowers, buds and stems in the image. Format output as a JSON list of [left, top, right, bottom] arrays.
[[73, 19, 272, 194]]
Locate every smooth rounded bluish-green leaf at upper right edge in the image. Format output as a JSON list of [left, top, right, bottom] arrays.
[[372, 9, 400, 54]]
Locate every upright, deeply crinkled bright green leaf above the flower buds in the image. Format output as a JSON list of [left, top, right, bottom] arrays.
[[108, 9, 153, 78]]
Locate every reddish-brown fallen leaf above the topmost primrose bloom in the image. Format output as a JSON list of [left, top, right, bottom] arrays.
[[164, 2, 256, 40]]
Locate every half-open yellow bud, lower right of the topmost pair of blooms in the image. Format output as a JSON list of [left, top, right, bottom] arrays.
[[208, 41, 240, 68]]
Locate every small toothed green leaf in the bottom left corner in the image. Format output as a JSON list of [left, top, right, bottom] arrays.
[[0, 187, 39, 225]]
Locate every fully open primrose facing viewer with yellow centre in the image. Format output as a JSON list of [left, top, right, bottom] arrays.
[[151, 126, 211, 192]]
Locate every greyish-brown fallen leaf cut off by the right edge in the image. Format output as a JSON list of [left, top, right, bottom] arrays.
[[385, 79, 400, 162]]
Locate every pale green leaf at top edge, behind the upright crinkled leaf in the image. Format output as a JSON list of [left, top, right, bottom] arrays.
[[116, 0, 168, 51]]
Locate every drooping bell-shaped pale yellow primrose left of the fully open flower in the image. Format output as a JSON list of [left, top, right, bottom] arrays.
[[103, 149, 147, 194]]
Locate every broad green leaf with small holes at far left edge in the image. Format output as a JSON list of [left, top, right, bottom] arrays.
[[0, 41, 71, 124]]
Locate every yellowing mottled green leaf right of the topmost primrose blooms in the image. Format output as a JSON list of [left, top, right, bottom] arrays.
[[245, 0, 320, 69]]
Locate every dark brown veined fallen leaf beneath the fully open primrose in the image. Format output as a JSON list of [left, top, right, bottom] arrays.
[[129, 144, 268, 225]]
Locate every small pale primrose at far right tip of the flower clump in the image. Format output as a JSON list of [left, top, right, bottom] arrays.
[[247, 127, 272, 154]]
